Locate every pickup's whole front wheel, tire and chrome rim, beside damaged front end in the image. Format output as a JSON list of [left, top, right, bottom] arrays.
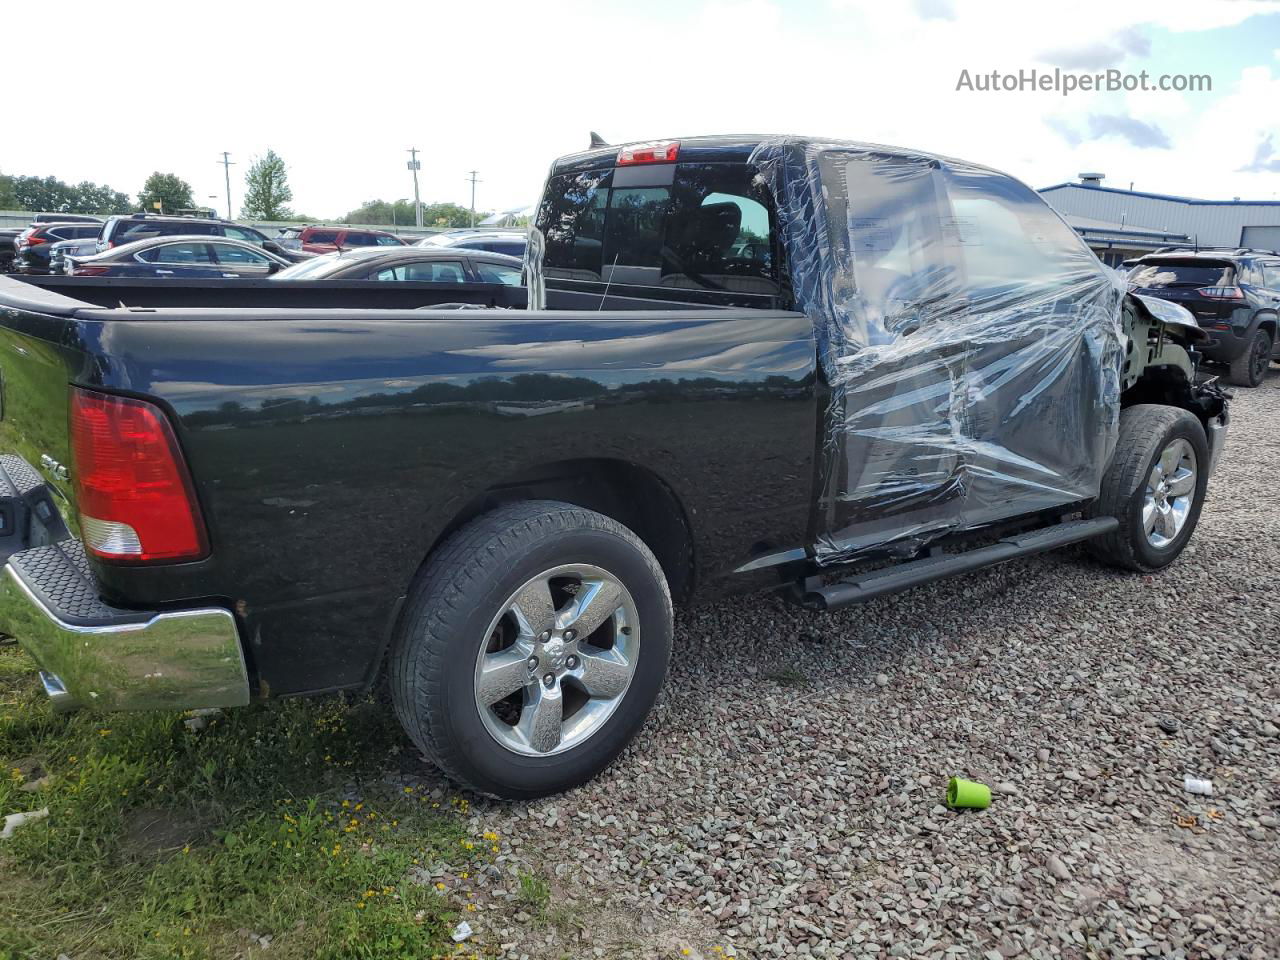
[[1089, 403, 1208, 572]]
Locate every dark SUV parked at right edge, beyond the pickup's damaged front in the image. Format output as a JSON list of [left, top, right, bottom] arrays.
[[1129, 247, 1280, 387]]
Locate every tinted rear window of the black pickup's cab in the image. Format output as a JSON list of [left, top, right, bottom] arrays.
[[535, 164, 778, 294]]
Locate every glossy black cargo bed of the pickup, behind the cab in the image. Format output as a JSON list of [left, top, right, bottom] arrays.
[[0, 278, 819, 695]]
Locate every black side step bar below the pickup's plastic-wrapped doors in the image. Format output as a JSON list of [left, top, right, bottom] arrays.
[[804, 517, 1120, 611]]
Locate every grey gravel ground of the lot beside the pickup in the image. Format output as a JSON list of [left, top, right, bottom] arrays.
[[396, 367, 1280, 960]]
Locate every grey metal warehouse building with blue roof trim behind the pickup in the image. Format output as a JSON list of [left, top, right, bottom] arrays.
[[1041, 173, 1280, 264]]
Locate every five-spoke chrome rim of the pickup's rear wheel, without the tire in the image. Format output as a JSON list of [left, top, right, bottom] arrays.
[[475, 563, 640, 756]]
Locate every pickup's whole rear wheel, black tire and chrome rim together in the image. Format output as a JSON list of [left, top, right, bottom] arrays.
[[390, 500, 672, 799]]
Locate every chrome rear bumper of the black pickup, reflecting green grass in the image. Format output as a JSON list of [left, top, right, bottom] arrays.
[[0, 540, 250, 710]]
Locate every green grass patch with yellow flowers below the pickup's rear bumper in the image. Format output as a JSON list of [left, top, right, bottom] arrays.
[[0, 645, 495, 960]]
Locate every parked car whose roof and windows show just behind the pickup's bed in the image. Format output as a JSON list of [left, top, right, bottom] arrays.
[[273, 247, 521, 287]]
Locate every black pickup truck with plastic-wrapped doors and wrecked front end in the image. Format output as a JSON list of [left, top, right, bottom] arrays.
[[0, 137, 1228, 797]]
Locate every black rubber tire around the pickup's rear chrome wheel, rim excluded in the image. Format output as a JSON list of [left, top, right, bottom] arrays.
[[389, 500, 672, 800]]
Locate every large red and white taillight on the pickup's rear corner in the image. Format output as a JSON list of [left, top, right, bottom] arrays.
[[70, 387, 209, 563]]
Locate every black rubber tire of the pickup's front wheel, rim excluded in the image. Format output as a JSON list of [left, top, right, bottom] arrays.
[[1089, 403, 1208, 572]]
